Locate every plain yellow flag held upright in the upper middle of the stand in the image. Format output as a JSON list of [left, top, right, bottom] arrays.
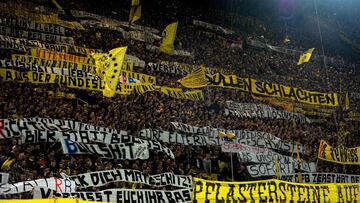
[[160, 22, 178, 55]]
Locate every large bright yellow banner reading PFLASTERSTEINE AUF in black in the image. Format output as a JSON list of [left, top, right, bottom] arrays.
[[193, 178, 360, 203]]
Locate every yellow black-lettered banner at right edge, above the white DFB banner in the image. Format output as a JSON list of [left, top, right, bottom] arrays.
[[318, 140, 360, 165]]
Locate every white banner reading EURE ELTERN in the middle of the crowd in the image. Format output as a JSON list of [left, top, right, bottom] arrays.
[[139, 129, 220, 146]]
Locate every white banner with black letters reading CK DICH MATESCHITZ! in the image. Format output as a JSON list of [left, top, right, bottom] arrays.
[[68, 169, 192, 188]]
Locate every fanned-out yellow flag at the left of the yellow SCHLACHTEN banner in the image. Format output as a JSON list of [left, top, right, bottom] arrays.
[[178, 67, 207, 88]]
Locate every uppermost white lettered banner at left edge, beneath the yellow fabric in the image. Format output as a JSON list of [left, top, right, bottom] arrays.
[[0, 18, 65, 35]]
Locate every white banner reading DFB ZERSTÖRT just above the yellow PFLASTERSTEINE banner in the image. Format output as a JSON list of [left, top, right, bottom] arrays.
[[279, 173, 360, 184]]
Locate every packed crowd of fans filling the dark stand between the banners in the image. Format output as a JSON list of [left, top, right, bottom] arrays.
[[0, 0, 360, 198]]
